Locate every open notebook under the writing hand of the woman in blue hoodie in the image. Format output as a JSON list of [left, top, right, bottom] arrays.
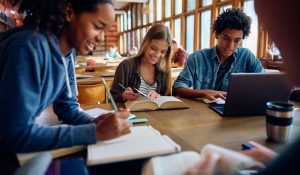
[[87, 126, 181, 165]]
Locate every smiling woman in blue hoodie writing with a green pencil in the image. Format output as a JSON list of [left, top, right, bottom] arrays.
[[0, 0, 131, 174]]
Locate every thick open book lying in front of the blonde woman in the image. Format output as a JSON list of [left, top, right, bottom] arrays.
[[125, 96, 188, 111]]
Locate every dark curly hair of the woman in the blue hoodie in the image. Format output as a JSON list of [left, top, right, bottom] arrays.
[[10, 0, 112, 35]]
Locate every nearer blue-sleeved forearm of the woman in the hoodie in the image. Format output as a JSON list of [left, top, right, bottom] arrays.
[[0, 124, 96, 152]]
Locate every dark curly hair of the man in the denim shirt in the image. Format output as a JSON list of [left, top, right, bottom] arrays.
[[213, 8, 252, 39]]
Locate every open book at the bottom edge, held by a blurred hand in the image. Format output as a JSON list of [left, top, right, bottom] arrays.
[[141, 144, 259, 175]]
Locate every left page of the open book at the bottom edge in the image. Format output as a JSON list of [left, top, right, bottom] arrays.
[[141, 151, 200, 175]]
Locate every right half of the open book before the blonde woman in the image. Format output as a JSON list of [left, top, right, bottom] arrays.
[[154, 96, 188, 109]]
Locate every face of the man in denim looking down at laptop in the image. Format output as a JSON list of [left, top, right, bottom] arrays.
[[216, 29, 243, 60]]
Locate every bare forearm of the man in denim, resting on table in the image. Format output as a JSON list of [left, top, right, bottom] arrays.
[[173, 88, 206, 98]]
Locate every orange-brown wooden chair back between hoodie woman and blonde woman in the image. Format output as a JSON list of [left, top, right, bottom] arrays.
[[77, 83, 106, 105]]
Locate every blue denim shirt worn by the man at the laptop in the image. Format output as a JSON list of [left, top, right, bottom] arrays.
[[173, 47, 264, 91]]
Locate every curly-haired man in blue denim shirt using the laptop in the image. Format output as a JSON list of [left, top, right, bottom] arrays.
[[173, 8, 264, 100]]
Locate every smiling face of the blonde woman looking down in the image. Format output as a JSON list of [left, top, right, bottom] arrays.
[[142, 39, 169, 64]]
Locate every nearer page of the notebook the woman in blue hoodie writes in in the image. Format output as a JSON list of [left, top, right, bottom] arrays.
[[87, 136, 180, 165]]
